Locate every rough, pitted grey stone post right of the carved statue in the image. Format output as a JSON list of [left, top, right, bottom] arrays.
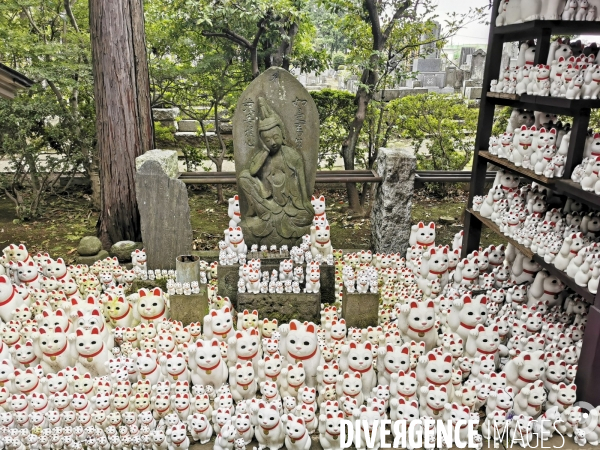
[[371, 148, 417, 255]]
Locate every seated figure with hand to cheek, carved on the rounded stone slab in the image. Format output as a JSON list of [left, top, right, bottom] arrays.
[[238, 97, 314, 246]]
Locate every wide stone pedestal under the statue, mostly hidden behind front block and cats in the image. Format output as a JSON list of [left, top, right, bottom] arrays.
[[217, 258, 335, 309]]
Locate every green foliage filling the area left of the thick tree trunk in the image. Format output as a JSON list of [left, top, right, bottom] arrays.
[[0, 0, 96, 218]]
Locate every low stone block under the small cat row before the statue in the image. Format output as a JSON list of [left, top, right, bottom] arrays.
[[237, 293, 321, 323]]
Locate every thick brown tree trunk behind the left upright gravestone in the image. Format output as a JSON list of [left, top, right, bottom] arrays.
[[89, 0, 154, 247]]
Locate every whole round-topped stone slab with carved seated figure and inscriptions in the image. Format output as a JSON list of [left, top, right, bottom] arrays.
[[233, 67, 319, 248]]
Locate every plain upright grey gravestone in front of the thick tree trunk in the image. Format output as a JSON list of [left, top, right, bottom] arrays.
[[135, 151, 192, 269]]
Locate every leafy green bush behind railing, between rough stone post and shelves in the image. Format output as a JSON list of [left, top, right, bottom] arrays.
[[391, 93, 478, 170]]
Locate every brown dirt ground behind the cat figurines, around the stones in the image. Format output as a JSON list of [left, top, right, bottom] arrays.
[[0, 186, 500, 261]]
